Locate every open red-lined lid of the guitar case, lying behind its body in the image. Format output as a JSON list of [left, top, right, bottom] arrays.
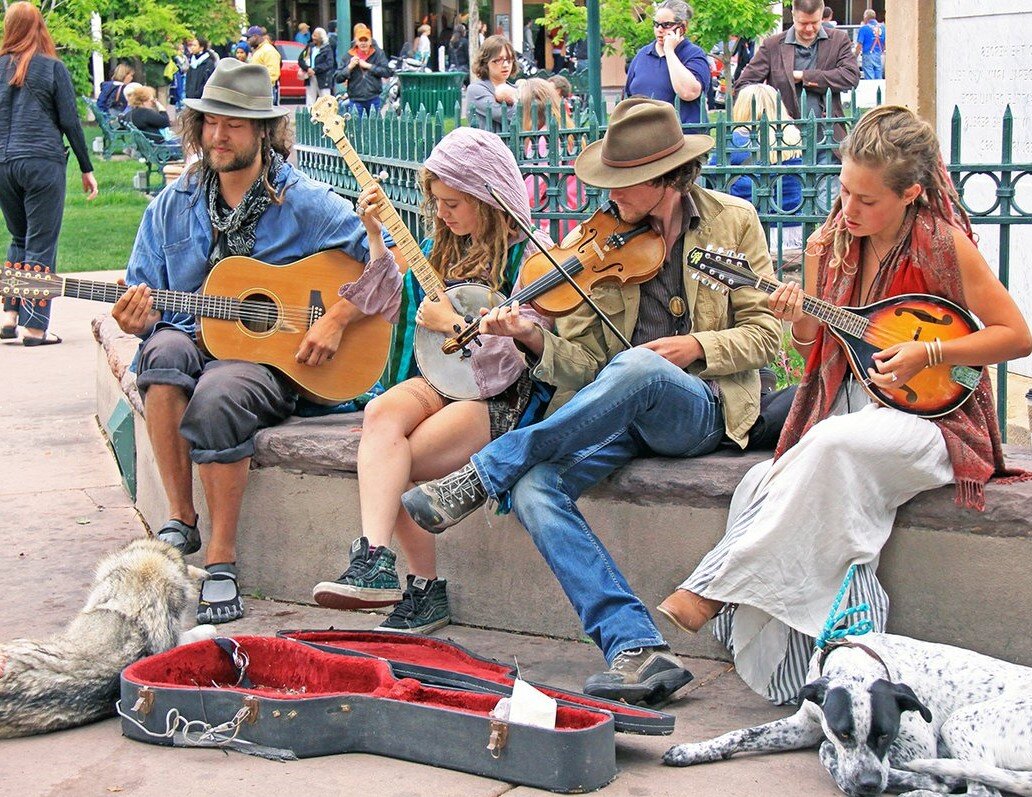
[[277, 629, 674, 736]]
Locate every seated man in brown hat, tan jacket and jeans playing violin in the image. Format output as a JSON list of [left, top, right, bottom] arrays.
[[402, 98, 781, 703]]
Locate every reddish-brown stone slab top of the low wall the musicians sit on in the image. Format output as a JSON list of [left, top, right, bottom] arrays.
[[93, 316, 1032, 538]]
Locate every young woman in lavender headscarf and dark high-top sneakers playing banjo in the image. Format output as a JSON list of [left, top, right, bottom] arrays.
[[313, 127, 551, 634]]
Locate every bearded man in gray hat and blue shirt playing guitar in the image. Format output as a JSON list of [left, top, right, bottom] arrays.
[[111, 58, 369, 623]]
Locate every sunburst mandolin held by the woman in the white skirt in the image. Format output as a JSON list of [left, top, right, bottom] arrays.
[[687, 247, 982, 418]]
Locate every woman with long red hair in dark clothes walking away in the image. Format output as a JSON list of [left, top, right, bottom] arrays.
[[0, 2, 97, 346]]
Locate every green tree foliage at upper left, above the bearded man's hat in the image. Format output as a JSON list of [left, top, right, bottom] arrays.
[[3, 0, 244, 94]]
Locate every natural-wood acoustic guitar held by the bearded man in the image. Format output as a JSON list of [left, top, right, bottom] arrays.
[[0, 250, 391, 405]]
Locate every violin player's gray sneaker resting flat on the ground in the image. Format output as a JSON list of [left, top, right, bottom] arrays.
[[584, 645, 692, 706]]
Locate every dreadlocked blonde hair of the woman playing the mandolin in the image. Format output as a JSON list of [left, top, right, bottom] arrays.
[[807, 105, 972, 268]]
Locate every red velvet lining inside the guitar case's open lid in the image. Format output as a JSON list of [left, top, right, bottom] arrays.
[[289, 631, 655, 718]]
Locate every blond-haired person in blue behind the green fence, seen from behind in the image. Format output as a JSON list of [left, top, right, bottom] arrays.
[[722, 83, 803, 251]]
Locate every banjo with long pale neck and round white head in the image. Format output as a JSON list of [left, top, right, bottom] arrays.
[[312, 97, 506, 401]]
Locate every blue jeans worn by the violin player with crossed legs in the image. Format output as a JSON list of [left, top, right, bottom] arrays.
[[473, 348, 724, 663]]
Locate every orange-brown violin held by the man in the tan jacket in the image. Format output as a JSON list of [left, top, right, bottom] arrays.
[[441, 202, 667, 354]]
